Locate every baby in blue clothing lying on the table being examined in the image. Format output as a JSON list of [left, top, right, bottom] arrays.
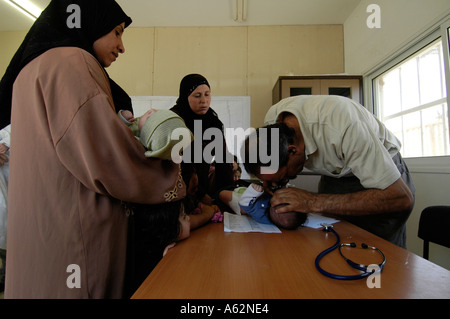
[[219, 183, 306, 230]]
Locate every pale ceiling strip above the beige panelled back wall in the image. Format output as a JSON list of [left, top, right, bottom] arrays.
[[0, 0, 360, 31]]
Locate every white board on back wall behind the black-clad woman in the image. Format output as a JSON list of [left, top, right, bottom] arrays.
[[131, 96, 250, 178]]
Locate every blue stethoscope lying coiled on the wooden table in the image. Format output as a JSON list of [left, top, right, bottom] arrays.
[[315, 224, 386, 280]]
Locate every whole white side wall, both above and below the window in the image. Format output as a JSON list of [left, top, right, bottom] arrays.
[[344, 0, 450, 269]]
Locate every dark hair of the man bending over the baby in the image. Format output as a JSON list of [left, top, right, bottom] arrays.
[[241, 123, 295, 175]]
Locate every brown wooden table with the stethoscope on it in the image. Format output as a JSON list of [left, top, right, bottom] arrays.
[[133, 222, 450, 299]]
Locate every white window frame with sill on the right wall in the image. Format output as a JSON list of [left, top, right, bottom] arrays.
[[363, 14, 450, 173]]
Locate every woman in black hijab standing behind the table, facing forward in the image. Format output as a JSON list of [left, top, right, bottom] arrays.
[[171, 74, 233, 198]]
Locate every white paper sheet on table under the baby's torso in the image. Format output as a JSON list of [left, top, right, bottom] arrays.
[[223, 212, 281, 233]]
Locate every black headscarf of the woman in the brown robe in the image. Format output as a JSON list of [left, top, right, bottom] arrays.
[[0, 0, 131, 128]]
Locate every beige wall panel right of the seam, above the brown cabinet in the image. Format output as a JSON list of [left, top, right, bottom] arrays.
[[247, 26, 344, 127]]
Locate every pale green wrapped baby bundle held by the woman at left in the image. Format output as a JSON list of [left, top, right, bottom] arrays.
[[138, 109, 193, 161]]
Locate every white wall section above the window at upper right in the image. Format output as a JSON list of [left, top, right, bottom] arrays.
[[344, 0, 450, 75]]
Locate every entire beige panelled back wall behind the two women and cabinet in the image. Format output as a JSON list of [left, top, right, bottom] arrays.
[[0, 25, 344, 127]]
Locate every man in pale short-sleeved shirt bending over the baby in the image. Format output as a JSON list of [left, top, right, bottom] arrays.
[[244, 96, 415, 247]]
